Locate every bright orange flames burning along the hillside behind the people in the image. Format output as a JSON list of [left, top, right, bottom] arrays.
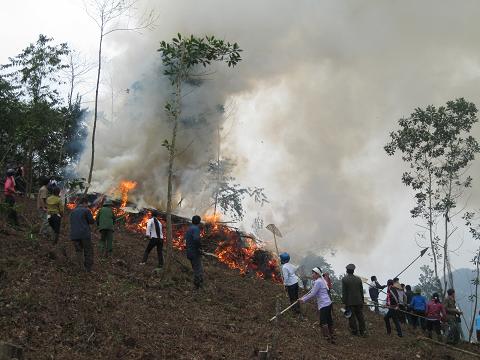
[[67, 180, 281, 282]]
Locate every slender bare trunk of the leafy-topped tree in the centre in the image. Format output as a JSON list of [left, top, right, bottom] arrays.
[[164, 77, 182, 279]]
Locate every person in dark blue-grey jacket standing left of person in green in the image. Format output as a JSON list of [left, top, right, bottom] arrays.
[[70, 197, 95, 272]]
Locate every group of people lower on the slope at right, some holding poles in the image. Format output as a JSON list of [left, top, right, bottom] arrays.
[[280, 253, 480, 343]]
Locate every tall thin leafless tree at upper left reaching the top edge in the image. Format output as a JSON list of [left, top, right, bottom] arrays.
[[84, 0, 155, 193]]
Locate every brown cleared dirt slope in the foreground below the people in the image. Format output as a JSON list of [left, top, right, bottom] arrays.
[[0, 200, 480, 360]]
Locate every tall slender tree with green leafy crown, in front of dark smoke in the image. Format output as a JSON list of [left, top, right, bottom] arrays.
[[158, 34, 241, 276]]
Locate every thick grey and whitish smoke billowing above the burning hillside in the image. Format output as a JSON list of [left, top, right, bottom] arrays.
[[75, 0, 480, 262]]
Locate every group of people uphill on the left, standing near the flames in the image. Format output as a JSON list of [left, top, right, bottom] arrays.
[[4, 169, 203, 289]]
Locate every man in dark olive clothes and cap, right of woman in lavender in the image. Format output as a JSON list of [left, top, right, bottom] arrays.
[[342, 264, 366, 336]]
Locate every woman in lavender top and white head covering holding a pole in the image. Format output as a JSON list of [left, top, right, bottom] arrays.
[[299, 267, 335, 344]]
